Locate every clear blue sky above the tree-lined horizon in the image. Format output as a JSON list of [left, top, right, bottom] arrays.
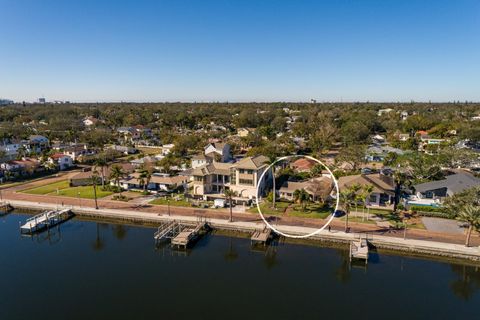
[[0, 0, 480, 101]]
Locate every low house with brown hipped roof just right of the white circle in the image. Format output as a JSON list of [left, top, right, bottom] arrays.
[[338, 173, 395, 206]]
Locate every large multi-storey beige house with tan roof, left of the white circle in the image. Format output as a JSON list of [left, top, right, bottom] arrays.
[[190, 156, 271, 202]]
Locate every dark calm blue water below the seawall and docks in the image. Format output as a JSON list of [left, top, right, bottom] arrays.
[[0, 214, 480, 320]]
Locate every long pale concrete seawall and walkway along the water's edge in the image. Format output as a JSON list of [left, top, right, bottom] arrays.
[[9, 200, 480, 263]]
